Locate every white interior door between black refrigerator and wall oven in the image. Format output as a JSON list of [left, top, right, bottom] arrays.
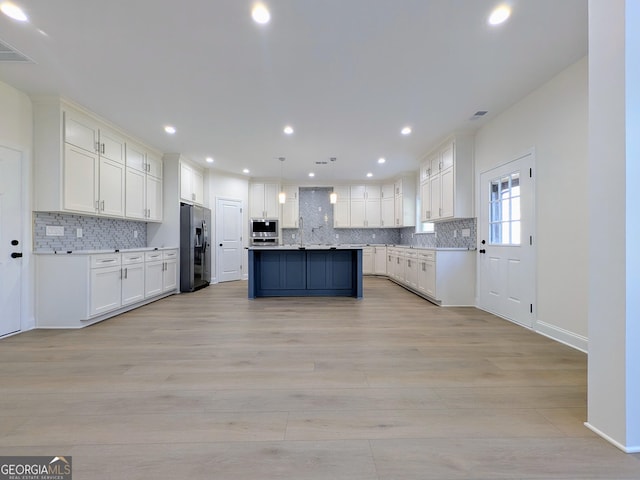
[[216, 198, 243, 282]]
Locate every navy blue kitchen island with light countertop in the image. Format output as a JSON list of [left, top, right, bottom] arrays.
[[249, 245, 362, 298]]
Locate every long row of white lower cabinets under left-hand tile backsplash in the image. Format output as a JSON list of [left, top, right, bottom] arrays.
[[36, 249, 178, 328]]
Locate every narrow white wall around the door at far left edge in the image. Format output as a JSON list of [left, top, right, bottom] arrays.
[[0, 82, 35, 331]]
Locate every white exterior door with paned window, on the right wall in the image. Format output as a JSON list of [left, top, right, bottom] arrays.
[[478, 153, 536, 328]]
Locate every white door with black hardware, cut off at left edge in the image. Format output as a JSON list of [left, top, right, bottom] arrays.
[[0, 146, 24, 336]]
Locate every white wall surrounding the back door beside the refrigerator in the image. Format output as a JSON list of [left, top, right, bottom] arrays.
[[205, 169, 249, 279]]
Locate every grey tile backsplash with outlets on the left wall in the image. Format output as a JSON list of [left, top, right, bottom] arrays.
[[33, 212, 147, 252]]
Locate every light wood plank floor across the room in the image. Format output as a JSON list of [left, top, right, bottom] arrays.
[[0, 278, 640, 480]]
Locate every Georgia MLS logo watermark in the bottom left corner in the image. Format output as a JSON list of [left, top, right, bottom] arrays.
[[0, 457, 72, 480]]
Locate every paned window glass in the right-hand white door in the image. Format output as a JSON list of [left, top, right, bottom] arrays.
[[489, 172, 521, 245]]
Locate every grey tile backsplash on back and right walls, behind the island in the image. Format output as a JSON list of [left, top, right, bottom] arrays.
[[282, 187, 476, 248]]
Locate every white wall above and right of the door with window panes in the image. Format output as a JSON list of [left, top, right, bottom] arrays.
[[475, 58, 588, 350]]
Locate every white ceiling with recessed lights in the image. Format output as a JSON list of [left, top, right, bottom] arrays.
[[0, 0, 587, 185]]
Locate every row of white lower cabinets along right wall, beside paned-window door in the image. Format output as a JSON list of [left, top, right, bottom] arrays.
[[387, 247, 476, 306]]
